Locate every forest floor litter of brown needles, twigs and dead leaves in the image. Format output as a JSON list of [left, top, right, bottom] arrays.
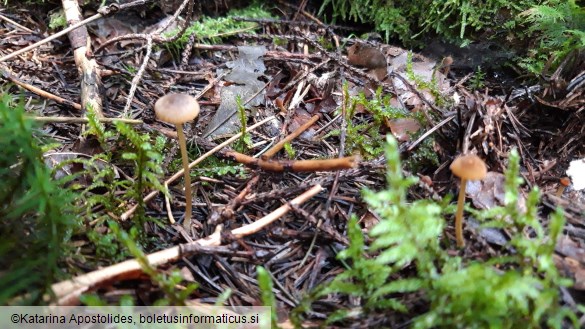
[[0, 0, 585, 326]]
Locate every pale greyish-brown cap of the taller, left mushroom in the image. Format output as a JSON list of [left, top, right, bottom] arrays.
[[154, 94, 199, 125]]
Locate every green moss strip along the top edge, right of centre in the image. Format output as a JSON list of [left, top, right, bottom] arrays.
[[320, 0, 539, 45]]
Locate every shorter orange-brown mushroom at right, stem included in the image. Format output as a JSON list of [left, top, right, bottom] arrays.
[[450, 154, 487, 247]]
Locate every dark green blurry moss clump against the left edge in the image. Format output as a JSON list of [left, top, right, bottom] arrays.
[[0, 94, 80, 305]]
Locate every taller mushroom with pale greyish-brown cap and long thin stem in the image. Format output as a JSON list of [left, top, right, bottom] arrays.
[[154, 94, 199, 234]]
